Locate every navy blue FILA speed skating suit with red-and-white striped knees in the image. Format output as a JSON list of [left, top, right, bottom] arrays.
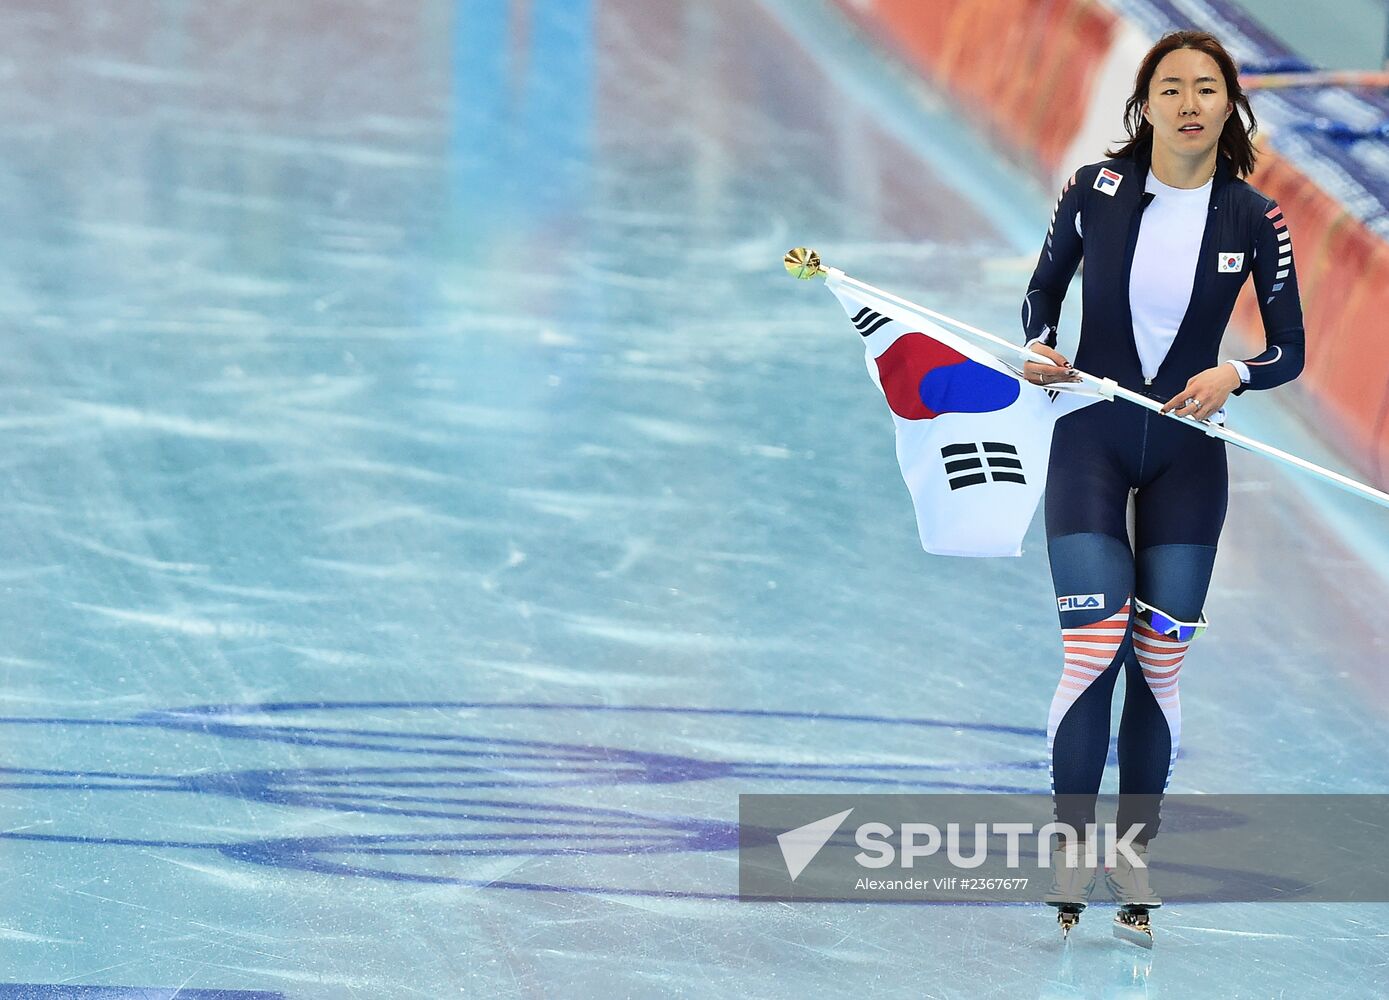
[[1022, 144, 1303, 843]]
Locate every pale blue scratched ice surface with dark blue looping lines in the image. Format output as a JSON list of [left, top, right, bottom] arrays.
[[0, 0, 1389, 999]]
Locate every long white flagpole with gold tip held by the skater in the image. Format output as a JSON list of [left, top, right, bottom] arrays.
[[783, 247, 1389, 507]]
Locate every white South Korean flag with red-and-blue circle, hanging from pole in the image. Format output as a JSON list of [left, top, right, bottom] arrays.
[[826, 271, 1101, 556]]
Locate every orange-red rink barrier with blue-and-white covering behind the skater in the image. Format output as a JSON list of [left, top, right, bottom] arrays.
[[835, 0, 1389, 486]]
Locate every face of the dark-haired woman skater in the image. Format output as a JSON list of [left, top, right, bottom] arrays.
[[1143, 49, 1235, 160]]
